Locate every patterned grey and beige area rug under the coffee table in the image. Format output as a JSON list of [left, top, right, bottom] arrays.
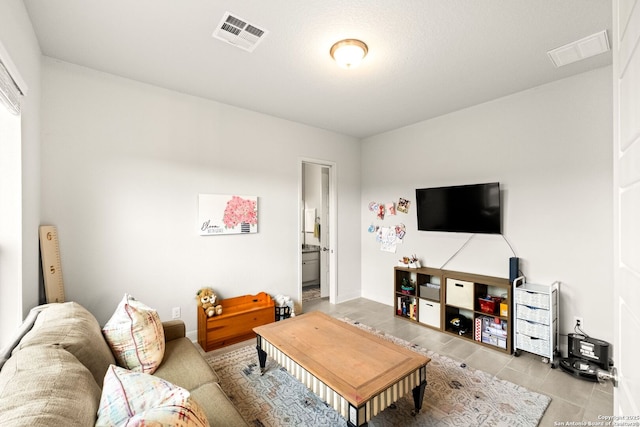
[[206, 319, 551, 427]]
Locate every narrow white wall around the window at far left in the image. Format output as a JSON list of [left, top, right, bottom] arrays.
[[0, 0, 41, 344]]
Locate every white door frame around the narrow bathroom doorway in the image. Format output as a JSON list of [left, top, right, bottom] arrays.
[[296, 157, 338, 310]]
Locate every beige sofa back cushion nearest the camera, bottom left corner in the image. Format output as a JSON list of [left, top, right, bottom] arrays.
[[0, 345, 100, 427]]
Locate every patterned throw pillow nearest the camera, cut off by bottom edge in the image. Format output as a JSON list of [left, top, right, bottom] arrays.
[[96, 365, 209, 427]]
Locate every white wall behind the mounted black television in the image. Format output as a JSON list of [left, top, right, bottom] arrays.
[[360, 67, 613, 341]]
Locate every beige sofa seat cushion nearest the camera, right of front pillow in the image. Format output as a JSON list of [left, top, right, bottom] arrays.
[[191, 383, 249, 427]]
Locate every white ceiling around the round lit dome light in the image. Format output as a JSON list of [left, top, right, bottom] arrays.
[[24, 0, 612, 138]]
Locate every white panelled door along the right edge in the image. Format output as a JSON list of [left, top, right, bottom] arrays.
[[612, 0, 640, 414]]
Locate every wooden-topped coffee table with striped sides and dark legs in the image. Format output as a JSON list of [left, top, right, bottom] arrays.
[[253, 311, 431, 426]]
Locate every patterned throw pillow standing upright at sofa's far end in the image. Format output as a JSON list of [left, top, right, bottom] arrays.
[[102, 294, 165, 374]]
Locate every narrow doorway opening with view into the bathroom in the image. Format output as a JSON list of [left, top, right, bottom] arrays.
[[298, 159, 337, 309]]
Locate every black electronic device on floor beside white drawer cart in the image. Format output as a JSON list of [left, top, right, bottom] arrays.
[[559, 334, 613, 382]]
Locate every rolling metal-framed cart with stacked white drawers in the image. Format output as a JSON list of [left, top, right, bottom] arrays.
[[513, 276, 560, 369]]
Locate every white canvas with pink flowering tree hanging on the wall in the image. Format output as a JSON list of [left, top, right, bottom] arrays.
[[198, 194, 258, 236]]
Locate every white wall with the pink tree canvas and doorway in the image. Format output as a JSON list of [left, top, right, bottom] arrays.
[[42, 58, 360, 336]]
